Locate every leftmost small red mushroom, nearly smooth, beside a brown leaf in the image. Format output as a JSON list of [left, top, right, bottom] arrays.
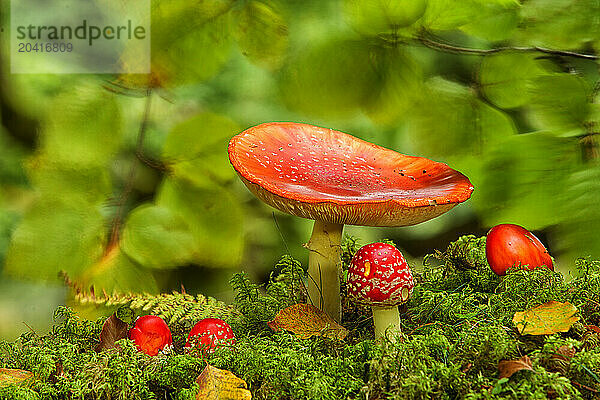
[[129, 315, 173, 356]]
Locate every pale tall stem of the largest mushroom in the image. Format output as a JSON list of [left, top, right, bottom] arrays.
[[306, 220, 344, 322]]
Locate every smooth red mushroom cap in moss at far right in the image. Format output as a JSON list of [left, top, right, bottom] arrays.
[[485, 224, 554, 275]]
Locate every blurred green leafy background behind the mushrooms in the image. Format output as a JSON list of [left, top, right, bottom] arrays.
[[0, 0, 600, 339]]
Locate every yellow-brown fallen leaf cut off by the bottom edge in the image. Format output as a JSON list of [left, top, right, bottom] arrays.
[[196, 365, 252, 400]]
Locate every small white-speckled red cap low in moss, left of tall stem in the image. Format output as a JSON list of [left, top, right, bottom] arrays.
[[185, 318, 235, 354]]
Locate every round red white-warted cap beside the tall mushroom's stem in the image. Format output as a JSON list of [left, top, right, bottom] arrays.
[[348, 243, 415, 307]]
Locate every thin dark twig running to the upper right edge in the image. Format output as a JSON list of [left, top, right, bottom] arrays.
[[416, 35, 600, 60]]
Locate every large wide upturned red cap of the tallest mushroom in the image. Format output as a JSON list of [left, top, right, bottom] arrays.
[[229, 122, 473, 226]]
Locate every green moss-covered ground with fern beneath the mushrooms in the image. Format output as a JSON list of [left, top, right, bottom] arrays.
[[0, 236, 600, 400]]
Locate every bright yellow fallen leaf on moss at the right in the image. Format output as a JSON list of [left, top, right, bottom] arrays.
[[513, 301, 579, 335]]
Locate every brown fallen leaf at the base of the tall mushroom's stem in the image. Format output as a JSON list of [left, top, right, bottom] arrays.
[[268, 304, 348, 340]]
